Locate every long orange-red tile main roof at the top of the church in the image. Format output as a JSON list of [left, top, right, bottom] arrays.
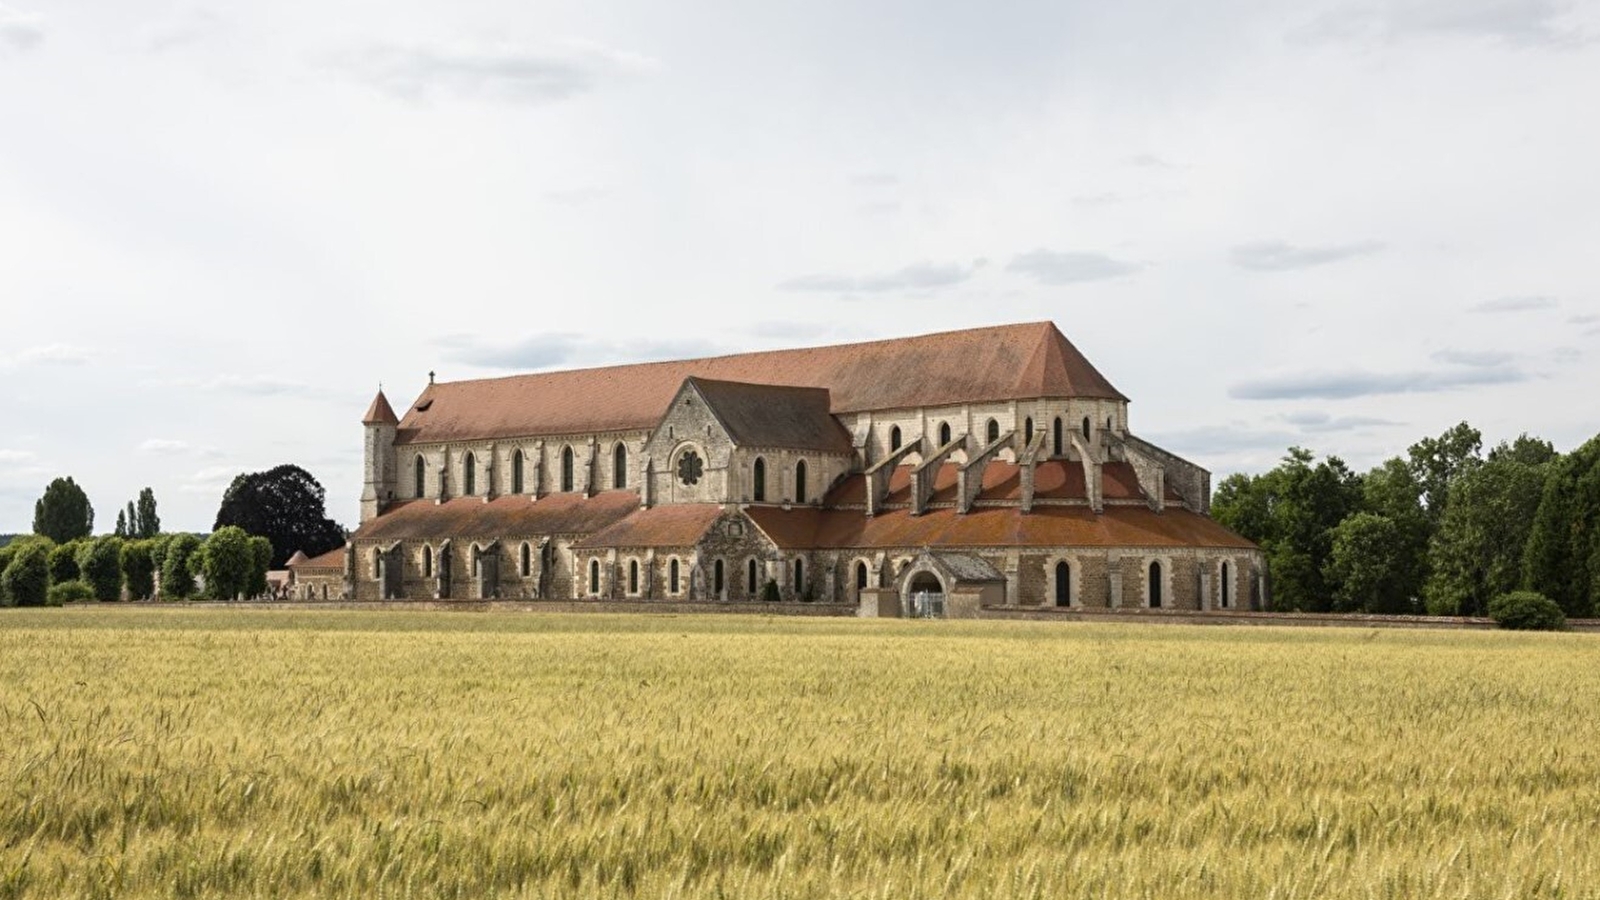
[[392, 322, 1126, 444]]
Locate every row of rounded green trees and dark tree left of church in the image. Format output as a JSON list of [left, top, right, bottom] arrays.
[[0, 466, 346, 605]]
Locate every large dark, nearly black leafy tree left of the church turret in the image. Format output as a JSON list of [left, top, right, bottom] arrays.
[[214, 464, 344, 569]]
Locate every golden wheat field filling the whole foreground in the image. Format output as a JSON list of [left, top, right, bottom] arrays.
[[0, 609, 1600, 900]]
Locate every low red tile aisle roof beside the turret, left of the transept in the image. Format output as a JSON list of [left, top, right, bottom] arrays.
[[350, 490, 638, 541]]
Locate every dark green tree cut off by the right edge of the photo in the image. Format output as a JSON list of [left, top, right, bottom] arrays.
[[1522, 436, 1600, 618]]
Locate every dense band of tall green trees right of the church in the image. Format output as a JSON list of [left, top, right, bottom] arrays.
[[1211, 423, 1600, 618]]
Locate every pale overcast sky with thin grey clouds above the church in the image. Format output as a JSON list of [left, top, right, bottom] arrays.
[[0, 0, 1600, 532]]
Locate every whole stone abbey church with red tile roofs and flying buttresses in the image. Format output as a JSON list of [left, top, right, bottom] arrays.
[[291, 322, 1264, 617]]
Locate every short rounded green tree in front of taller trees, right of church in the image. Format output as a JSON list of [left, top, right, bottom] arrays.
[[1323, 512, 1416, 613]]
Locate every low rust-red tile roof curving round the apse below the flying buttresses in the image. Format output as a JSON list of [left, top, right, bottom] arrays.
[[747, 506, 1256, 549]]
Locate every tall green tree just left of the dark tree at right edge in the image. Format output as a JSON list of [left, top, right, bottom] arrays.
[[1424, 434, 1555, 615]]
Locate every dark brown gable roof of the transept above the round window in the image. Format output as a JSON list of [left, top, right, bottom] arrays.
[[690, 378, 851, 453]]
